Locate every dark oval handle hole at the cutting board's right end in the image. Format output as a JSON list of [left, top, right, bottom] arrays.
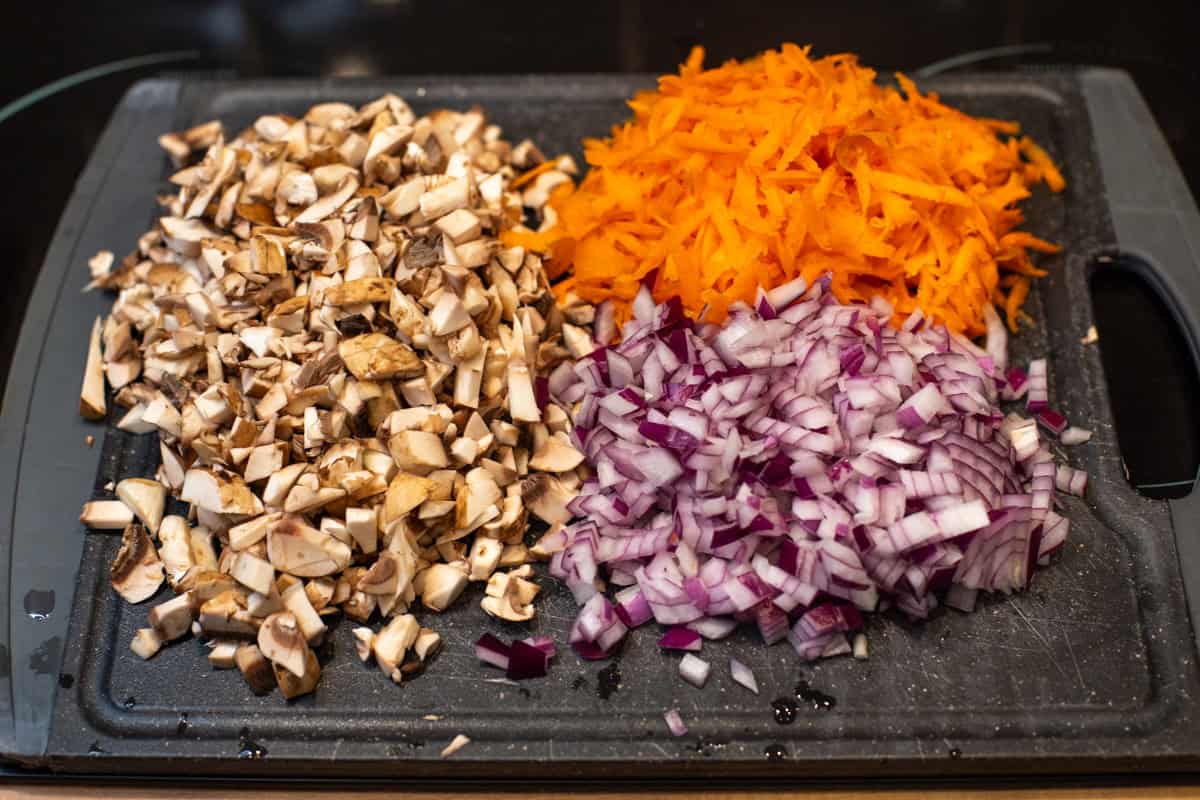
[[1091, 254, 1200, 499]]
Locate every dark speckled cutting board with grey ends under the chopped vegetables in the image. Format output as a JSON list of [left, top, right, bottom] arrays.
[[7, 71, 1200, 780]]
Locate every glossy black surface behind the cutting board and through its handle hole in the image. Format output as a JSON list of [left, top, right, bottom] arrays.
[[0, 0, 1200, 495]]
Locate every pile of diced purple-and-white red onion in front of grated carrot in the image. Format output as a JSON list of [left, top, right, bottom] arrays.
[[540, 279, 1087, 666]]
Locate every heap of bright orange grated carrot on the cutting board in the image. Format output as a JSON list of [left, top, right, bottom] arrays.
[[504, 44, 1064, 336]]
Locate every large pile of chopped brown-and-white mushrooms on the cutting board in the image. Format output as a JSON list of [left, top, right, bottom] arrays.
[[80, 95, 594, 698]]
